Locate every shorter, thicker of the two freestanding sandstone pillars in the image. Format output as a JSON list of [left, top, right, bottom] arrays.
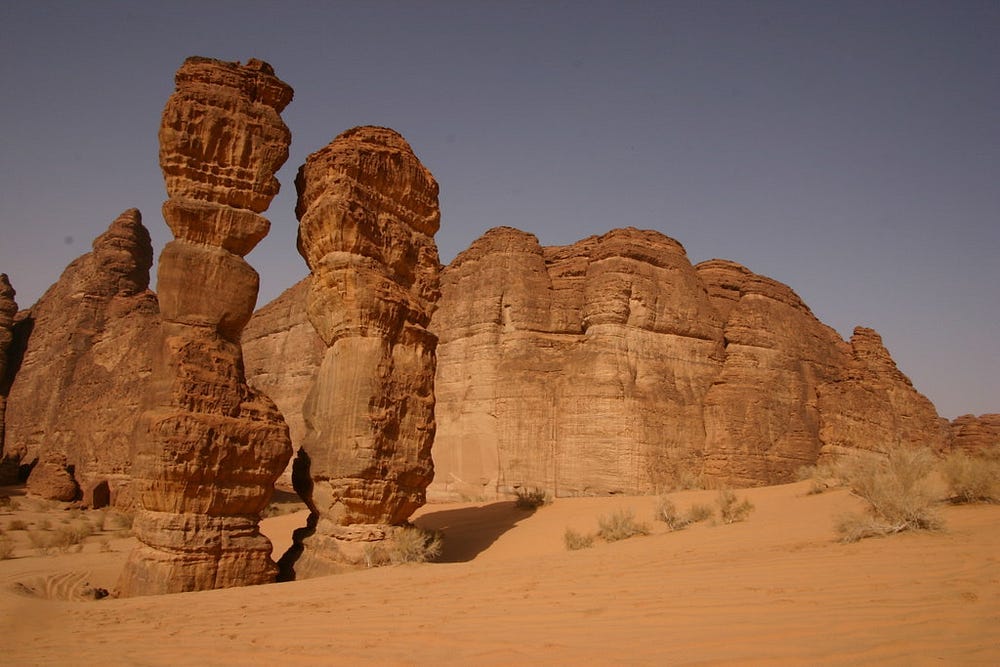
[[285, 127, 440, 576]]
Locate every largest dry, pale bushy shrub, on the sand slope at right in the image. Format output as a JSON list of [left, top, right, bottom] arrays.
[[836, 447, 943, 542]]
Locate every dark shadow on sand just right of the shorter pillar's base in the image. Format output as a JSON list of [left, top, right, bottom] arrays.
[[413, 500, 534, 563]]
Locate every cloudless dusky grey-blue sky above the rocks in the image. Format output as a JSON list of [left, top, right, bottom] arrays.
[[0, 0, 1000, 417]]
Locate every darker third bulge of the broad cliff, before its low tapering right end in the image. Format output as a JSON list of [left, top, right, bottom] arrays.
[[696, 260, 850, 486]]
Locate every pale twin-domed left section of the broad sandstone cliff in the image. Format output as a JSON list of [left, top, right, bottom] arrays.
[[432, 228, 723, 497]]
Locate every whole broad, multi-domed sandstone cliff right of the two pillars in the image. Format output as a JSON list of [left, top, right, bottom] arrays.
[[248, 227, 949, 499]]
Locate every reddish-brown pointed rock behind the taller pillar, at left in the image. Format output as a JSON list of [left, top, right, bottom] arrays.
[[4, 209, 158, 504]]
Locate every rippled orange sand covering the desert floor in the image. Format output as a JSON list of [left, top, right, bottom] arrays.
[[0, 482, 1000, 665]]
